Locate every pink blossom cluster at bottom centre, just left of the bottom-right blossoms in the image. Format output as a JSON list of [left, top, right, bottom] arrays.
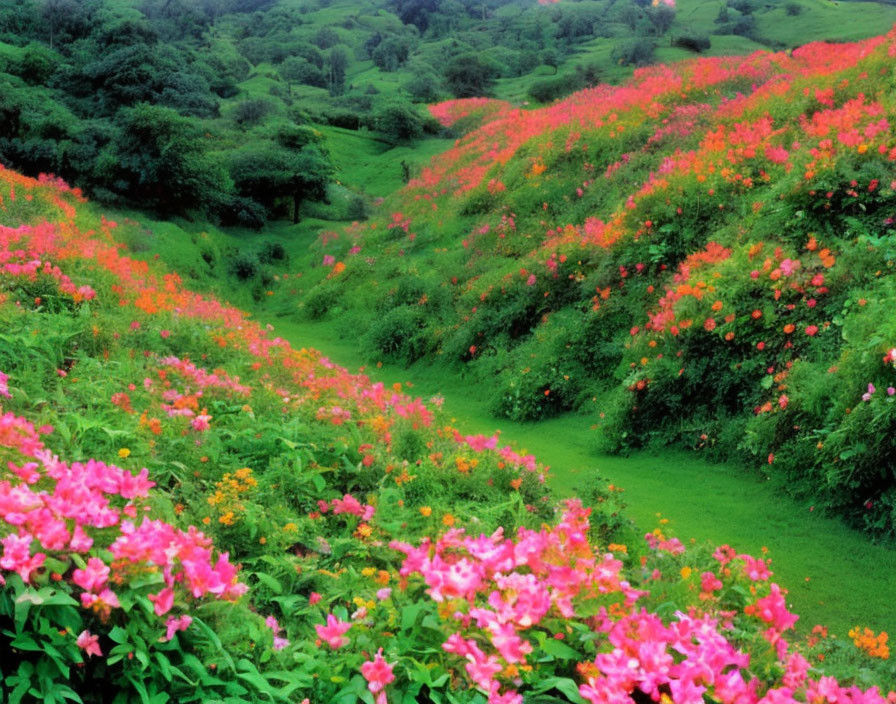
[[391, 500, 640, 703]]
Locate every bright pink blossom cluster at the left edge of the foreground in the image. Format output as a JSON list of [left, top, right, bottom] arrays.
[[0, 384, 246, 647]]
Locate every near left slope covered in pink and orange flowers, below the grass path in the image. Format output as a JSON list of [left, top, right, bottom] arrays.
[[0, 151, 893, 704]]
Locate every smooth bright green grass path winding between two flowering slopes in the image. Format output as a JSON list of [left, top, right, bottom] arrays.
[[252, 311, 896, 637]]
